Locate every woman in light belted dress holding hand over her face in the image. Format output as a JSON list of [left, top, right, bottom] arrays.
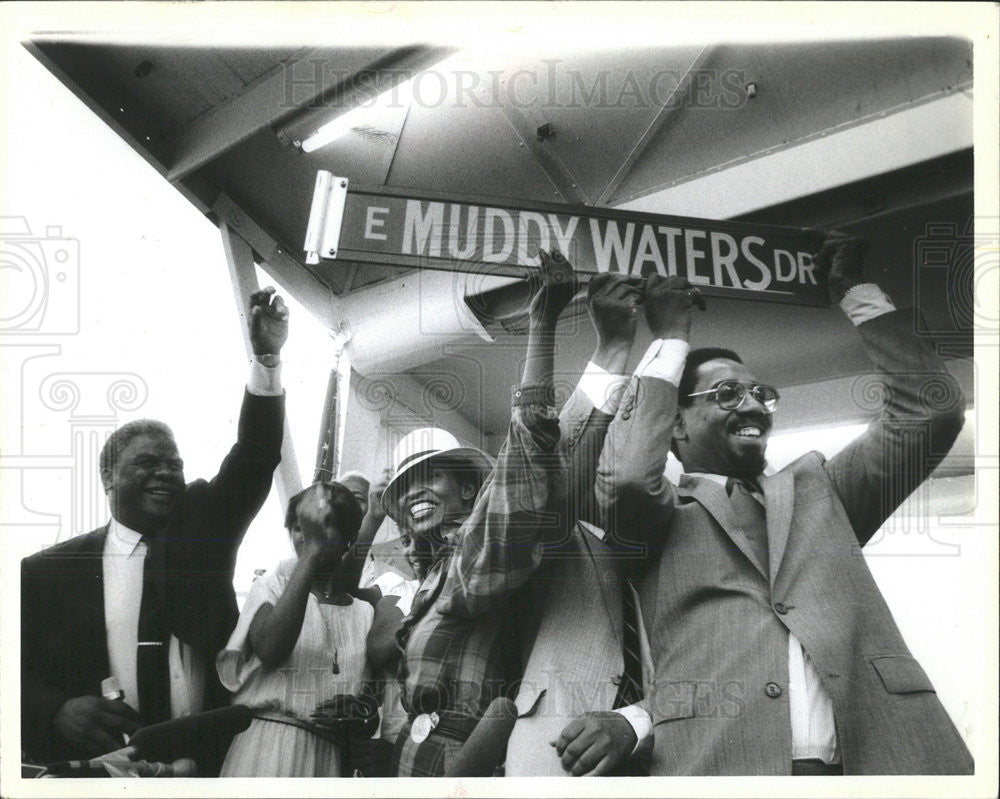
[[217, 483, 374, 777]]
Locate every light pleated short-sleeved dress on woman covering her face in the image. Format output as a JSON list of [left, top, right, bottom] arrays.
[[216, 558, 375, 777]]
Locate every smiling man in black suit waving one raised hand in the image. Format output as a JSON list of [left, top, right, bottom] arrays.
[[21, 287, 288, 776]]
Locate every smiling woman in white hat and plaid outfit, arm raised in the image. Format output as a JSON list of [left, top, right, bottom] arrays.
[[369, 251, 577, 777]]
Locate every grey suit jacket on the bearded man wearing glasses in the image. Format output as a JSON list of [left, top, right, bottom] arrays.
[[597, 311, 973, 774]]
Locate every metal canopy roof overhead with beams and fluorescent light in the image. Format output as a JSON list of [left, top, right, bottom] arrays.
[[26, 25, 973, 446]]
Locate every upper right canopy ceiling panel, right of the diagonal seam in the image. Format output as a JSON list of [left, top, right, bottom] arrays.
[[611, 39, 972, 204]]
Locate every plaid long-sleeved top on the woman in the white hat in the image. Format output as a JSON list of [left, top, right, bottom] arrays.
[[396, 392, 562, 776]]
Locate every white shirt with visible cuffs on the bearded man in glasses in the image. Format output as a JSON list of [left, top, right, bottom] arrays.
[[628, 283, 895, 763]]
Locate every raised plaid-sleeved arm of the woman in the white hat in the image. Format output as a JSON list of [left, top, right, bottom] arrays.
[[438, 251, 577, 616]]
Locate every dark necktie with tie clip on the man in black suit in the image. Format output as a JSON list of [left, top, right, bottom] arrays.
[[135, 536, 170, 726]]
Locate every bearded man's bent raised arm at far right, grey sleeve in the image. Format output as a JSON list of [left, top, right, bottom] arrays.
[[816, 232, 965, 545]]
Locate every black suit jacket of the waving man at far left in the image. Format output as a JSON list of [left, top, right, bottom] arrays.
[[21, 393, 284, 761]]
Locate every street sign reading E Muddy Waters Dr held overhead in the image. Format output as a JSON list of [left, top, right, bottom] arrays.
[[328, 188, 829, 305]]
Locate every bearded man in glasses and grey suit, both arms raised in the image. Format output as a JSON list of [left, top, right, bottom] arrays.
[[556, 233, 973, 775]]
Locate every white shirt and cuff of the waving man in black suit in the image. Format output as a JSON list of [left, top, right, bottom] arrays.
[[102, 358, 282, 718]]
